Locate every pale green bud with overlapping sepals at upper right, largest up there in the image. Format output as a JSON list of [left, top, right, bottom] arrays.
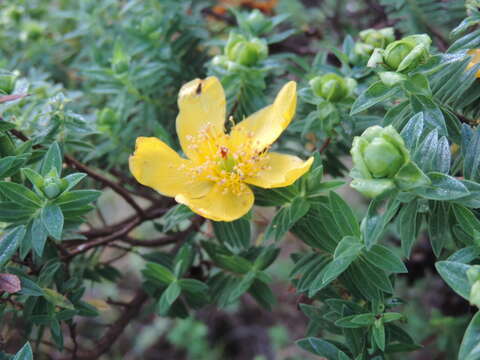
[[382, 34, 432, 72]]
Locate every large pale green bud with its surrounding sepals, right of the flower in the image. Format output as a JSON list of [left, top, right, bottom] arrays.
[[350, 126, 430, 197]]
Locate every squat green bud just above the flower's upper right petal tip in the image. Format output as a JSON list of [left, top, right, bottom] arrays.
[[310, 73, 356, 102]]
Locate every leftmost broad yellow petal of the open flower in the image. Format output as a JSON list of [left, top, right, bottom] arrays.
[[129, 137, 212, 197]]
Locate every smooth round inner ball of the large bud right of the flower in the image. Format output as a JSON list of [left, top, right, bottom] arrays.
[[363, 137, 403, 178]]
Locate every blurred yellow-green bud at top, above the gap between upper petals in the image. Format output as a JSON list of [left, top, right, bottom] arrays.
[[225, 33, 268, 66]]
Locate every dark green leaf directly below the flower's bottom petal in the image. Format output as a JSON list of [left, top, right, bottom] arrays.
[[212, 217, 251, 249]]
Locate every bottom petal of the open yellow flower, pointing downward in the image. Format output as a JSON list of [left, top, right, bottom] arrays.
[[175, 185, 254, 221]]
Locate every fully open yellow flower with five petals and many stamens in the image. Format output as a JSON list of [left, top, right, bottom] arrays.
[[130, 77, 313, 221]]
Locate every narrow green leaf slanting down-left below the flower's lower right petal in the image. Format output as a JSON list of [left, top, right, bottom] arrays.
[[265, 197, 310, 240]]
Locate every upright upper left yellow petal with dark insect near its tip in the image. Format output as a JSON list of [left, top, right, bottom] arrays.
[[177, 77, 226, 160]]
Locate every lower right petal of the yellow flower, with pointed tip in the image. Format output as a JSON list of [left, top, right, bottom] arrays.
[[245, 152, 313, 189]]
